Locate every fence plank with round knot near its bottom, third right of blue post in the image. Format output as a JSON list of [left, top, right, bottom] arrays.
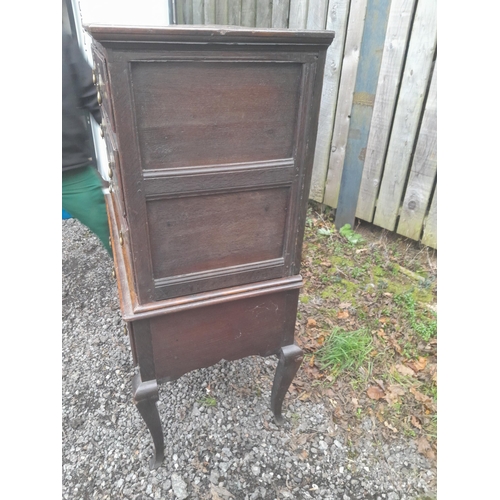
[[397, 60, 437, 240]]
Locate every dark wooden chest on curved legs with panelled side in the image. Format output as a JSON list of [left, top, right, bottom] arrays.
[[86, 25, 333, 466]]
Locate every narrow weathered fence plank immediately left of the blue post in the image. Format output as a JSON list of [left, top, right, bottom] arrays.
[[323, 0, 367, 208]]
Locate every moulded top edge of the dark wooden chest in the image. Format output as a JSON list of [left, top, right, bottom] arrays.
[[84, 24, 335, 46]]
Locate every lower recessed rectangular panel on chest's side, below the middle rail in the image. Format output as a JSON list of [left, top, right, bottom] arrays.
[[147, 188, 290, 279]]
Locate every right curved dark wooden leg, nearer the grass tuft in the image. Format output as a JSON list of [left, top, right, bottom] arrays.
[[271, 344, 304, 425]]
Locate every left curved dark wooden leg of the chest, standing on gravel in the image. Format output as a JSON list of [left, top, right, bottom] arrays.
[[132, 373, 165, 469]]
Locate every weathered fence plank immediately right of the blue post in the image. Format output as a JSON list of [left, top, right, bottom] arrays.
[[356, 0, 416, 222]]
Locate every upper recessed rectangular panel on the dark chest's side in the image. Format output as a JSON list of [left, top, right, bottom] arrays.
[[131, 61, 302, 170]]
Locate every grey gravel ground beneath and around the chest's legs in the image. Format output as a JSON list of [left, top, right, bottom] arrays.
[[62, 219, 436, 500]]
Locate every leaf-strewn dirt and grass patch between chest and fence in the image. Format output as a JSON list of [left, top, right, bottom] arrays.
[[290, 206, 437, 461]]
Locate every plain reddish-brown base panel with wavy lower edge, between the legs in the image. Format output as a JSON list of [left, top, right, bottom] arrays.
[[150, 290, 299, 380]]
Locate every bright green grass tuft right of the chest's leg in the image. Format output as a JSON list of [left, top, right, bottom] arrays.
[[316, 328, 373, 377]]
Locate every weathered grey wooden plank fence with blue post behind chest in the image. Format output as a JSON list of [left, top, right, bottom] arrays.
[[173, 0, 437, 248]]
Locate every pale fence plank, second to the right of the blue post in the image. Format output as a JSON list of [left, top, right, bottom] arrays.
[[374, 0, 436, 231]]
